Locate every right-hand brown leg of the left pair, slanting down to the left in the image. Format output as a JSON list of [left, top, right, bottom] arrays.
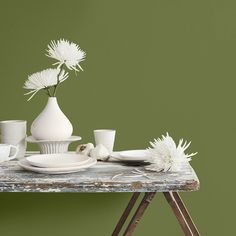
[[124, 193, 156, 236]]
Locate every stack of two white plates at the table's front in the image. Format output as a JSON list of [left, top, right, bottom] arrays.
[[18, 153, 97, 174]]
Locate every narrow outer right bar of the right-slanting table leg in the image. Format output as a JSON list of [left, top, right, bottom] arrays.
[[173, 192, 200, 236]]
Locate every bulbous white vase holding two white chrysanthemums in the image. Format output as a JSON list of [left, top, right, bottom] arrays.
[[24, 39, 86, 141]]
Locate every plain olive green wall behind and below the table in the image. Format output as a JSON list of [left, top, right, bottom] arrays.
[[0, 0, 236, 236]]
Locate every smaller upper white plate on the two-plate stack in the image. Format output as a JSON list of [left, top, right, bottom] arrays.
[[26, 153, 89, 168]]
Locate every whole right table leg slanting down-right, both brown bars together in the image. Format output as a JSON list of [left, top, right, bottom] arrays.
[[163, 192, 200, 236]]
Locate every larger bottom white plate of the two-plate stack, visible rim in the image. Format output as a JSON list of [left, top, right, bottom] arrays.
[[18, 158, 97, 175]]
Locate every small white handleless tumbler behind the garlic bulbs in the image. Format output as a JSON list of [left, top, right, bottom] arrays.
[[93, 129, 116, 153]]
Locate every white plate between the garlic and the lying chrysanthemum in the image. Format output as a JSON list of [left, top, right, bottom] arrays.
[[111, 150, 150, 162]]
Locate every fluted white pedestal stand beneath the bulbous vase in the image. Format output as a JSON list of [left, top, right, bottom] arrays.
[[26, 136, 81, 154]]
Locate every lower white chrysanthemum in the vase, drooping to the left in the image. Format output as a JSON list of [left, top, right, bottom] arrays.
[[23, 69, 68, 101]]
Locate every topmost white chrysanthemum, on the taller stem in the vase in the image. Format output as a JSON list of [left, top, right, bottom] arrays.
[[46, 39, 86, 71]]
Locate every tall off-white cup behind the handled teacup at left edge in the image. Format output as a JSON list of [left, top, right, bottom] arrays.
[[0, 120, 26, 159]]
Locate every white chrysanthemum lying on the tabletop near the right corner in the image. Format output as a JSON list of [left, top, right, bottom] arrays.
[[148, 133, 197, 171]]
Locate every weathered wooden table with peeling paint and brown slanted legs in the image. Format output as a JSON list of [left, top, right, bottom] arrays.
[[0, 158, 199, 236]]
